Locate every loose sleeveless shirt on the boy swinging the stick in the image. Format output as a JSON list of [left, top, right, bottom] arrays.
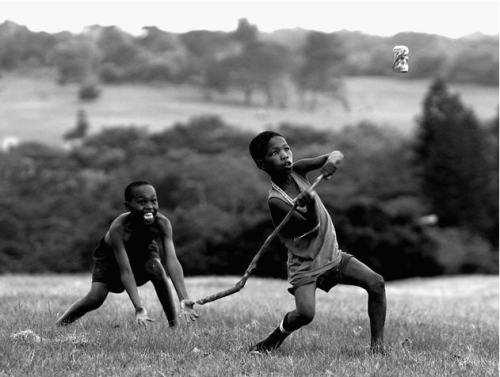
[[268, 172, 341, 285]]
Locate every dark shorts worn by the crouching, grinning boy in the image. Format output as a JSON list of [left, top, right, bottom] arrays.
[[92, 238, 160, 293]]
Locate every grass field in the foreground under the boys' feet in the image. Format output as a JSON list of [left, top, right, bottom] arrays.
[[0, 274, 499, 377]]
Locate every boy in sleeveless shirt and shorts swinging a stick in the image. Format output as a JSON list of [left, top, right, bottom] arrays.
[[249, 131, 386, 353]]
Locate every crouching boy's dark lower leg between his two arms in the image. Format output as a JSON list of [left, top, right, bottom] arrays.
[[144, 258, 177, 327]]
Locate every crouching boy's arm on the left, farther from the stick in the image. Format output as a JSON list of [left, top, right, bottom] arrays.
[[109, 226, 152, 325]]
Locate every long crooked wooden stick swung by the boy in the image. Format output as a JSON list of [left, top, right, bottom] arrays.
[[196, 173, 328, 305]]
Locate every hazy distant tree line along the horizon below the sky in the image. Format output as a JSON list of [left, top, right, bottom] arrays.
[[0, 19, 499, 106]]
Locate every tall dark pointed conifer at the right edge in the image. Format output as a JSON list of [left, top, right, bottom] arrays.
[[415, 79, 493, 242]]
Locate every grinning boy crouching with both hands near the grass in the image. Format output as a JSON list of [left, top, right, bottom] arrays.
[[56, 181, 198, 326]]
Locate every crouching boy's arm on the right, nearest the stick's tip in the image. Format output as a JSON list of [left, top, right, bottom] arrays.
[[161, 217, 198, 321]]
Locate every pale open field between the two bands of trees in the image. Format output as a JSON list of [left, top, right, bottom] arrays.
[[0, 69, 499, 145]]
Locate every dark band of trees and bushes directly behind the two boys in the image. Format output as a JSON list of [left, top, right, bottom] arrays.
[[0, 79, 498, 280]]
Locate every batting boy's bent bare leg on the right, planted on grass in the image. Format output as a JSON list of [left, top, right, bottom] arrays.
[[340, 258, 387, 353]]
